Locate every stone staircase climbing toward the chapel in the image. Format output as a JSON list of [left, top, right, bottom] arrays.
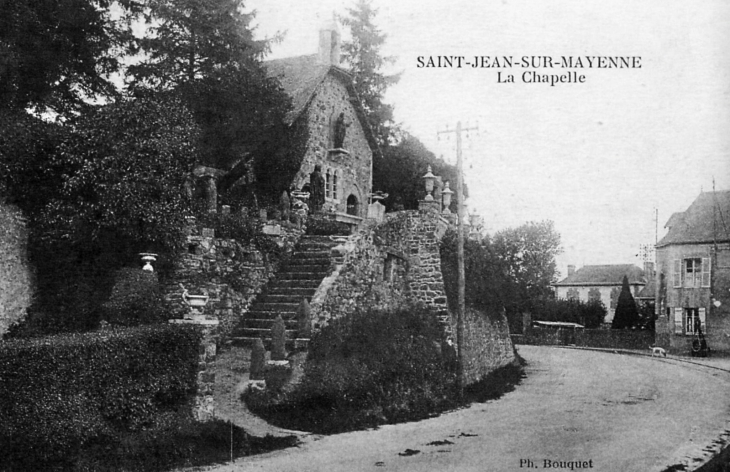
[[232, 235, 341, 348]]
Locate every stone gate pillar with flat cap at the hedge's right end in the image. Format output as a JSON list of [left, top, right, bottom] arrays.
[[170, 319, 219, 422]]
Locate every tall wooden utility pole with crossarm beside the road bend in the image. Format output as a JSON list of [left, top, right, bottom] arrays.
[[438, 121, 479, 397]]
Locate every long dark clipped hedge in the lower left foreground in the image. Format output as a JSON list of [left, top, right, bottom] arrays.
[[0, 325, 201, 467]]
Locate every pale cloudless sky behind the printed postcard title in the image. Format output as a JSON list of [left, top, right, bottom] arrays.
[[245, 0, 730, 276]]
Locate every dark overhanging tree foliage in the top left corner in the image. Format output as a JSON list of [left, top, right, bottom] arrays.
[[0, 0, 137, 112]]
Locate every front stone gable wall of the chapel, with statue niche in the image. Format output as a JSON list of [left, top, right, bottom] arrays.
[[294, 74, 373, 217]]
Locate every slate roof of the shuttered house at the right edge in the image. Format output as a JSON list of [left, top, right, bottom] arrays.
[[657, 190, 730, 247]]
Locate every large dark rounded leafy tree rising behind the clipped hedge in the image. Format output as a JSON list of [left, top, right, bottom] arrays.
[[9, 97, 196, 335]]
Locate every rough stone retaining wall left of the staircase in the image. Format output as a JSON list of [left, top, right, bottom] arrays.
[[165, 223, 302, 337]]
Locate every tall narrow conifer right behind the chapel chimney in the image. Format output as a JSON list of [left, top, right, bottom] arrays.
[[340, 0, 400, 146]]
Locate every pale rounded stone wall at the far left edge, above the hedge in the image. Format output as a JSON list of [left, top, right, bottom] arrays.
[[0, 203, 34, 337]]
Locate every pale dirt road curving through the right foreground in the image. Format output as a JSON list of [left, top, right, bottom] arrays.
[[202, 346, 730, 472]]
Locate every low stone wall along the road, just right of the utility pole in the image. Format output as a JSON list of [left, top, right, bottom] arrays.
[[452, 309, 516, 385]]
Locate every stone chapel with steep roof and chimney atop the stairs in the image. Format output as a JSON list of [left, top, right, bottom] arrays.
[[264, 20, 378, 224]]
